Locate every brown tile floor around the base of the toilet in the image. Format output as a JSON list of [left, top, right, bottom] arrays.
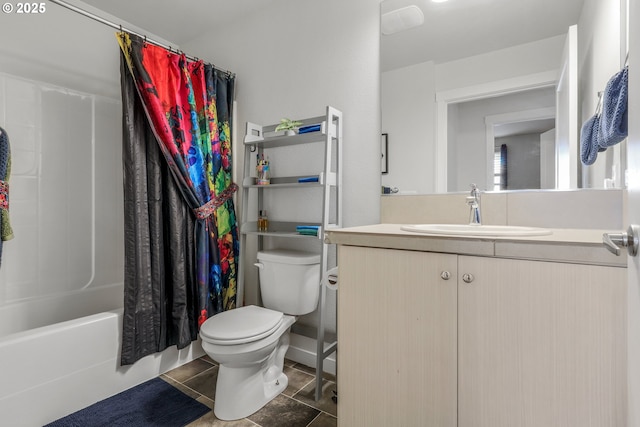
[[160, 356, 338, 427]]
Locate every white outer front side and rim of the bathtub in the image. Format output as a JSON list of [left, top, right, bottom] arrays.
[[0, 310, 204, 426]]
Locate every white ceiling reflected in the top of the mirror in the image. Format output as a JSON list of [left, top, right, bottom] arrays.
[[381, 0, 584, 71]]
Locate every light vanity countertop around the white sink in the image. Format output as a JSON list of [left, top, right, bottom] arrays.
[[325, 224, 627, 267]]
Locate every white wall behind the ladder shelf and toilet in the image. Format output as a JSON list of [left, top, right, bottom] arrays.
[[184, 0, 380, 338]]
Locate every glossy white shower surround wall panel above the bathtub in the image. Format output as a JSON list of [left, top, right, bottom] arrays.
[[0, 72, 123, 310]]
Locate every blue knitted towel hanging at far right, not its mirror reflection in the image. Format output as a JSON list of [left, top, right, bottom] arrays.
[[598, 67, 629, 149]]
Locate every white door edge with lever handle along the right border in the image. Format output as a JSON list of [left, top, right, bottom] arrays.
[[626, 1, 640, 427]]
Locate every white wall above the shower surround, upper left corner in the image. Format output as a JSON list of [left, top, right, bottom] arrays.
[[0, 1, 176, 99]]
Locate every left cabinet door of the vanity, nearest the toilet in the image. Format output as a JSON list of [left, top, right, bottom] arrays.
[[338, 246, 457, 427]]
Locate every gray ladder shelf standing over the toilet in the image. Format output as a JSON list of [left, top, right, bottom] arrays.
[[238, 106, 342, 400]]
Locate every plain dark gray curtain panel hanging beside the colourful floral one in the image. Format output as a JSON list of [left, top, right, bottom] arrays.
[[120, 53, 198, 365]]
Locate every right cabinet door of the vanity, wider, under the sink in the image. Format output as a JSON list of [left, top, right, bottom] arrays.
[[458, 257, 626, 427]]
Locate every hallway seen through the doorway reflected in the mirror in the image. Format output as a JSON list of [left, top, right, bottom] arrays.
[[447, 86, 556, 192]]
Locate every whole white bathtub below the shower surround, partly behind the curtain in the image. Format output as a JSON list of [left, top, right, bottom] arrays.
[[0, 284, 204, 427]]
